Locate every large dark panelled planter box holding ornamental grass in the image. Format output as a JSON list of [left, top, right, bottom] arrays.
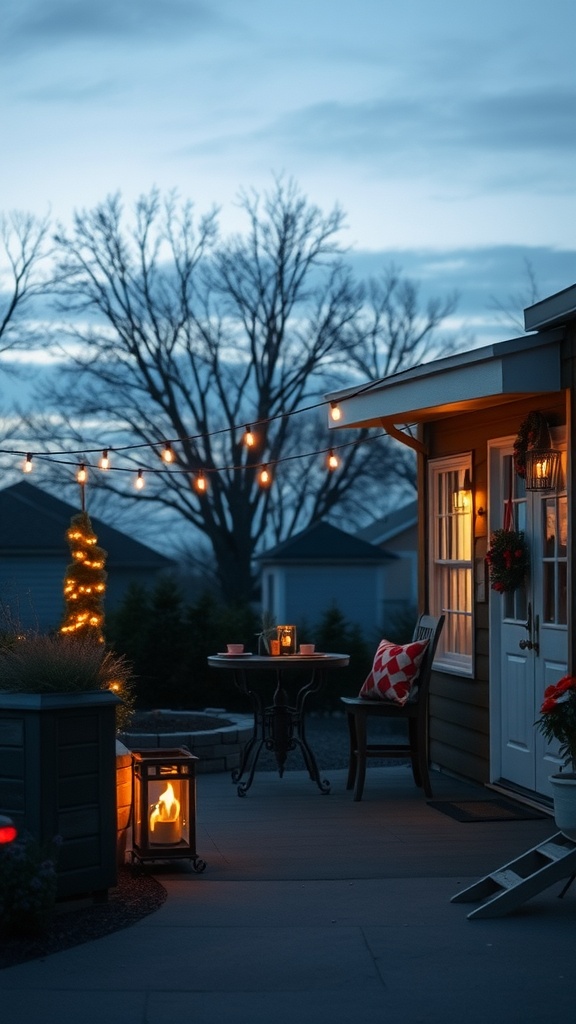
[[0, 690, 119, 898]]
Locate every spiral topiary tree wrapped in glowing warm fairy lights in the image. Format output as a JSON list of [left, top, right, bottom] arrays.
[[60, 511, 107, 643]]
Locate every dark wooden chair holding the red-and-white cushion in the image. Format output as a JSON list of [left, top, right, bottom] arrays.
[[340, 615, 445, 800]]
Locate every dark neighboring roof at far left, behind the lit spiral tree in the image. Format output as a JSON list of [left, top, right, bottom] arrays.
[[0, 480, 174, 569]]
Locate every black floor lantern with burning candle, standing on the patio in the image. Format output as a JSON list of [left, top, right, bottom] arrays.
[[132, 746, 206, 871]]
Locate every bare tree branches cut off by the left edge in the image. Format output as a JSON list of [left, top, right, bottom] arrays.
[[0, 212, 49, 353]]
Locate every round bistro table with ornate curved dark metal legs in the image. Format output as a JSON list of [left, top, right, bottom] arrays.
[[208, 653, 349, 797]]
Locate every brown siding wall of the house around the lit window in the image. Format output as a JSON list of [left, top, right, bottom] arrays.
[[419, 392, 567, 782]]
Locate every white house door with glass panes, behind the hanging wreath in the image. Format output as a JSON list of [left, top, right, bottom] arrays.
[[490, 443, 568, 796]]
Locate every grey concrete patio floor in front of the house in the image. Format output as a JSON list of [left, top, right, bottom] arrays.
[[0, 766, 576, 1024]]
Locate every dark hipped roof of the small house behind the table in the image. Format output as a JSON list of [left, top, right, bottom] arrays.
[[259, 521, 391, 564]]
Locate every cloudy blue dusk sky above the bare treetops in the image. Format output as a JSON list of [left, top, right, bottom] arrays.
[[0, 0, 576, 336]]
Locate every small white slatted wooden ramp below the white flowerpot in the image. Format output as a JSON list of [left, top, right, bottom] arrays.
[[450, 833, 576, 919]]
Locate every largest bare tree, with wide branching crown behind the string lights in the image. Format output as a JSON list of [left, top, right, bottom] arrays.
[[34, 180, 457, 600]]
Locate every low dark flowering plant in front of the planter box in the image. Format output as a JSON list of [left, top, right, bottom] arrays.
[[0, 834, 61, 935]]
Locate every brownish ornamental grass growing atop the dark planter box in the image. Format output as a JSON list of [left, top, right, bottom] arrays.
[[0, 631, 134, 729]]
